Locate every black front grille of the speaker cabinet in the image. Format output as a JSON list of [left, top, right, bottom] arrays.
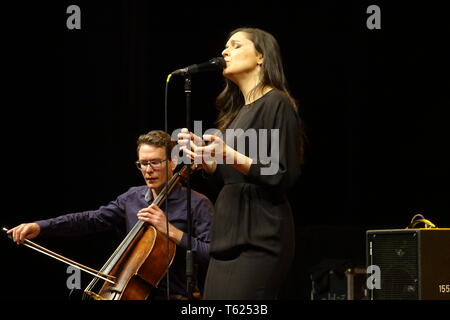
[[368, 231, 419, 300]]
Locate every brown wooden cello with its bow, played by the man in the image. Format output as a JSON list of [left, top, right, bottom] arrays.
[[3, 165, 196, 300]]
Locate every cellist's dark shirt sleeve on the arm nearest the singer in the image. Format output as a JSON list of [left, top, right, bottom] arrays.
[[179, 198, 214, 264]]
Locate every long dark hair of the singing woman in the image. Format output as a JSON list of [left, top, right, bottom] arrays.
[[216, 28, 305, 162]]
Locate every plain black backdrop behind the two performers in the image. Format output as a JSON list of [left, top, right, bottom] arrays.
[[0, 1, 450, 300]]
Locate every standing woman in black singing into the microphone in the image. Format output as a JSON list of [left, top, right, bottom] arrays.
[[178, 28, 303, 299]]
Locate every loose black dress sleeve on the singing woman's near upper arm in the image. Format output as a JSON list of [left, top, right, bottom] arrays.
[[247, 99, 301, 192]]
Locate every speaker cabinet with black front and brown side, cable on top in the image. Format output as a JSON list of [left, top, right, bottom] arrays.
[[366, 228, 450, 300]]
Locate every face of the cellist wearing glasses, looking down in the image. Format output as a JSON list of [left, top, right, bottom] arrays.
[[138, 144, 176, 193]]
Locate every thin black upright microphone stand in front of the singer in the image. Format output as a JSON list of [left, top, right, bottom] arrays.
[[184, 74, 194, 300]]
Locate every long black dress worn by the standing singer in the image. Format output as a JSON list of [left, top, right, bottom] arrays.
[[204, 89, 300, 299]]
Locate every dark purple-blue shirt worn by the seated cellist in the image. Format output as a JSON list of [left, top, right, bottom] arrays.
[[36, 184, 214, 295]]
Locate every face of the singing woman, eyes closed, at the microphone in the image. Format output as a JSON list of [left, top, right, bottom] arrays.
[[222, 31, 263, 81]]
